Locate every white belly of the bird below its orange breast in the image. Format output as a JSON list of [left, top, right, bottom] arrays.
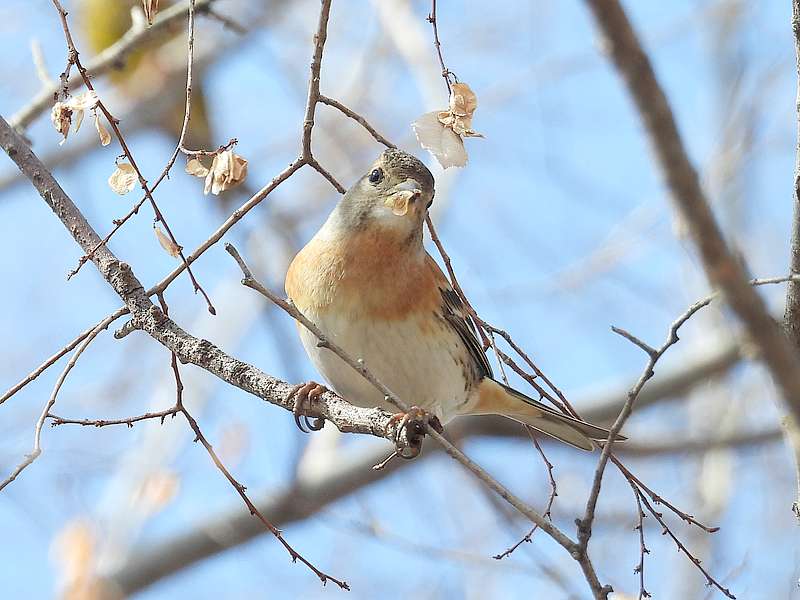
[[299, 312, 468, 423]]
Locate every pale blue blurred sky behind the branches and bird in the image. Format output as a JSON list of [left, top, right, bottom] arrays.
[[0, 0, 800, 600]]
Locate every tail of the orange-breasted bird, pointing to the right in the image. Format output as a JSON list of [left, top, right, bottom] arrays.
[[467, 377, 627, 451]]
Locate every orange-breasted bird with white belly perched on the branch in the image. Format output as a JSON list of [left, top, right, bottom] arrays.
[[285, 148, 625, 451]]
